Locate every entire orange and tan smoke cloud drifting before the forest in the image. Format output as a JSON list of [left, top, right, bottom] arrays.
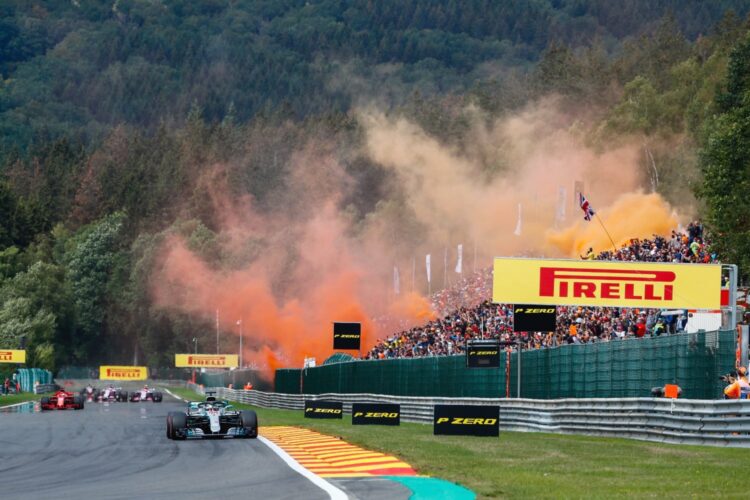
[[152, 102, 678, 375]]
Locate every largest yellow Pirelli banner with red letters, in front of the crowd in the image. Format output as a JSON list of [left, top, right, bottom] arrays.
[[492, 258, 721, 309]]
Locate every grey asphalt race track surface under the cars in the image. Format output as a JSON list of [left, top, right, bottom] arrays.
[[0, 393, 411, 500]]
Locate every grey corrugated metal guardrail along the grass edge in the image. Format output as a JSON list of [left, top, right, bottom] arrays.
[[198, 388, 750, 447]]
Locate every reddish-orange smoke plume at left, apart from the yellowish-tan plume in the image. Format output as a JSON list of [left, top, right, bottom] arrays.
[[152, 186, 430, 376]]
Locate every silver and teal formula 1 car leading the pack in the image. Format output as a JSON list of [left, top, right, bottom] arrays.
[[167, 396, 258, 439]]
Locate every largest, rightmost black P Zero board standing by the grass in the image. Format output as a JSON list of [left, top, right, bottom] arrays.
[[433, 405, 500, 437]]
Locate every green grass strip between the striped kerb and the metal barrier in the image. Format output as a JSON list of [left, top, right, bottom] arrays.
[[170, 388, 750, 498]]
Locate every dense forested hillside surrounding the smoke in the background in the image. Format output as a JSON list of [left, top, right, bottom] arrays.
[[0, 0, 750, 369]]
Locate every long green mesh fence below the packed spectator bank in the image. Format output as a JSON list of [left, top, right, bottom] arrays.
[[275, 331, 736, 399]]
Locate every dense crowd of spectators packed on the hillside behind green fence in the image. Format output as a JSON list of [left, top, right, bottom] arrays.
[[365, 222, 716, 359]]
